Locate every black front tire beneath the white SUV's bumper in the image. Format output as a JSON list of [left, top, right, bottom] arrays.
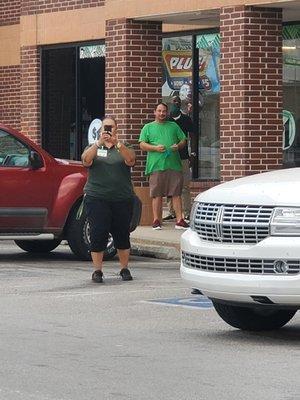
[[213, 300, 296, 331]]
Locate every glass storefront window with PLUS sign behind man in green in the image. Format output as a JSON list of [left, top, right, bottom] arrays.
[[162, 33, 220, 180]]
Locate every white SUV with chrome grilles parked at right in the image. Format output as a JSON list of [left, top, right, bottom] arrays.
[[181, 168, 300, 330]]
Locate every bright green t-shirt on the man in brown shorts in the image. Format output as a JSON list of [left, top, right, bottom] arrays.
[[139, 121, 186, 175]]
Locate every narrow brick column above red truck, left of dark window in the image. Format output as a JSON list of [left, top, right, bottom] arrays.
[[20, 46, 41, 143]]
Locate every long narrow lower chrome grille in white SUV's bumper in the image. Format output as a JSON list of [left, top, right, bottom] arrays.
[[181, 251, 300, 275]]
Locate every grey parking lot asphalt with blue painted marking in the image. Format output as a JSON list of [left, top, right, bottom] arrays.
[[0, 242, 300, 400]]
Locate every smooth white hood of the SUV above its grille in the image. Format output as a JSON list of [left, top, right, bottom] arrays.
[[195, 168, 300, 207]]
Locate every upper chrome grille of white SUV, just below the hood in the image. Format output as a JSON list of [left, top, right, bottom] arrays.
[[194, 203, 274, 244]]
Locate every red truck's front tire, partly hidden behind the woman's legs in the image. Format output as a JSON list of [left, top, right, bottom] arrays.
[[67, 208, 117, 261]]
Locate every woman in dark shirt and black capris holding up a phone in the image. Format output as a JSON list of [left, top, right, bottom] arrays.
[[81, 117, 135, 283]]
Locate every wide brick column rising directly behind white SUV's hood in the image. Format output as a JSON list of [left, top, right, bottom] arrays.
[[220, 6, 283, 180]]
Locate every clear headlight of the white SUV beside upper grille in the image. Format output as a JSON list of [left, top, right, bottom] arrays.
[[270, 207, 300, 236]]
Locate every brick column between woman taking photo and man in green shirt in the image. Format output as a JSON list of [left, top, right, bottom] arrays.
[[105, 19, 162, 186]]
